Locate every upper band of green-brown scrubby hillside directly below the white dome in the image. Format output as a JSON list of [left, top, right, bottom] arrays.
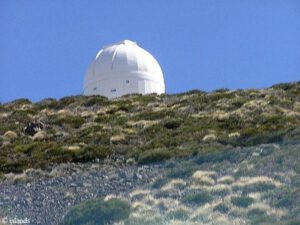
[[0, 82, 300, 173]]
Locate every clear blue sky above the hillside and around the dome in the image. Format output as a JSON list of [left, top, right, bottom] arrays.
[[0, 0, 300, 102]]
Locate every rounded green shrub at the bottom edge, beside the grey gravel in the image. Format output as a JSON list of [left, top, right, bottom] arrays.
[[60, 199, 131, 225]]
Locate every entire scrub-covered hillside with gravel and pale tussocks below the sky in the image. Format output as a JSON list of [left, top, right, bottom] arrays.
[[0, 82, 300, 225]]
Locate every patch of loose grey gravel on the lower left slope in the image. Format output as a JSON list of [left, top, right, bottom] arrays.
[[0, 160, 163, 225]]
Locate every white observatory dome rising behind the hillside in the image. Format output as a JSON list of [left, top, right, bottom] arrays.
[[84, 40, 165, 98]]
